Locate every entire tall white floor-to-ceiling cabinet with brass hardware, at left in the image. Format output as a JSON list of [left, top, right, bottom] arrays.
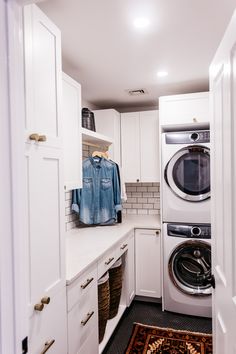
[[23, 5, 67, 354]]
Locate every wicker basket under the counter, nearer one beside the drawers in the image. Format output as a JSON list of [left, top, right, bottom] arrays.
[[98, 273, 110, 343]]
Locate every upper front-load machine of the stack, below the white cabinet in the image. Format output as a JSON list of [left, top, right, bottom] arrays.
[[161, 130, 210, 223]]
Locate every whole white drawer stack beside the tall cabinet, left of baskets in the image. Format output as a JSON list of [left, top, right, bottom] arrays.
[[67, 264, 98, 354]]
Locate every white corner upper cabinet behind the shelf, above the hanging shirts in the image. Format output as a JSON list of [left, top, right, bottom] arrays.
[[93, 109, 121, 165]]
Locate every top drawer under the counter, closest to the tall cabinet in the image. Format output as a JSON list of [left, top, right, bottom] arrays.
[[67, 267, 97, 311]]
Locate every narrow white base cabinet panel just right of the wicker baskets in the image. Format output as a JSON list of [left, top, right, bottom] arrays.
[[126, 231, 135, 306]]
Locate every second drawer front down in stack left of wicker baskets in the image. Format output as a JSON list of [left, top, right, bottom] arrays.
[[68, 293, 98, 354]]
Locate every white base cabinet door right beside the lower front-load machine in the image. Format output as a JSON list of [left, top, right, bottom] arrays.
[[135, 229, 161, 298]]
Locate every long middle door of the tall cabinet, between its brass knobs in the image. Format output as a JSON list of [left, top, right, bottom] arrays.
[[26, 147, 65, 310]]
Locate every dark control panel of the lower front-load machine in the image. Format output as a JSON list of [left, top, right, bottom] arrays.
[[167, 224, 211, 239]]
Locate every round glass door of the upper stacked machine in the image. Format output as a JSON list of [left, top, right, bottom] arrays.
[[165, 145, 210, 202]]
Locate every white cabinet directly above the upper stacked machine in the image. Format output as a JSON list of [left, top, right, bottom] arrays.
[[159, 92, 210, 129]]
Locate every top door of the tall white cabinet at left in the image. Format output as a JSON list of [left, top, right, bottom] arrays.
[[24, 5, 62, 147]]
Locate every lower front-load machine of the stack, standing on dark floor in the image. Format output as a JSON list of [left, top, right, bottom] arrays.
[[163, 223, 214, 317]]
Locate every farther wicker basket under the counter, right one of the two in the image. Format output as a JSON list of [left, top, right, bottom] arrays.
[[109, 258, 122, 319]]
